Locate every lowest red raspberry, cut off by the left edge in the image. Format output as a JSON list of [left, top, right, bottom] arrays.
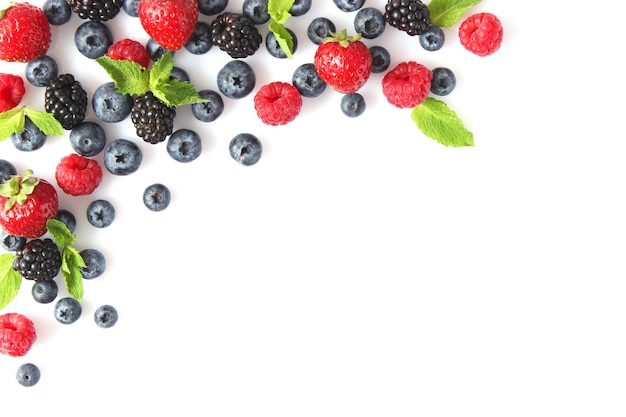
[[0, 313, 37, 356]]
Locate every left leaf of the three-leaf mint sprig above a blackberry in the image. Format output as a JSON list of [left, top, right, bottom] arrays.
[[96, 55, 150, 96]]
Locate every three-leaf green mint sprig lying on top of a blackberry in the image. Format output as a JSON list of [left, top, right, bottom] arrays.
[[96, 51, 206, 107]]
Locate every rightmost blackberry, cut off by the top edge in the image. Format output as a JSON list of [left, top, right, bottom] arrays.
[[385, 0, 430, 36]]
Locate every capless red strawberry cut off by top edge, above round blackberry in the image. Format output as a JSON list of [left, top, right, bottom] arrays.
[[137, 0, 198, 51]]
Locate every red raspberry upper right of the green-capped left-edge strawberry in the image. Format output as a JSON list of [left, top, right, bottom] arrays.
[[55, 153, 102, 195]]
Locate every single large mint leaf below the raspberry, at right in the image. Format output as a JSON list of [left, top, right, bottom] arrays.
[[411, 97, 474, 147]]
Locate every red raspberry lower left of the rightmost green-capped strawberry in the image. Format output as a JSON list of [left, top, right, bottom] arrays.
[[254, 81, 302, 126]]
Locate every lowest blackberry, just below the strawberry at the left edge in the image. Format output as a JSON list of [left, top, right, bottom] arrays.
[[13, 238, 62, 281]]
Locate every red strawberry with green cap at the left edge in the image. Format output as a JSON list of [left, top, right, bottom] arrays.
[[0, 170, 59, 239]]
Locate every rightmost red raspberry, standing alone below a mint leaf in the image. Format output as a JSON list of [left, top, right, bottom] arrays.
[[459, 13, 502, 56]]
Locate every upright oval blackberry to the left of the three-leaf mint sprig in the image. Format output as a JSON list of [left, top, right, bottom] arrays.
[[45, 74, 87, 130]]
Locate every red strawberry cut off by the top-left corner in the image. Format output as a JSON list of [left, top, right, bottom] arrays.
[[0, 2, 51, 62]]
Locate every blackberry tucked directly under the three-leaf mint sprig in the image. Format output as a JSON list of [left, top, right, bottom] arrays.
[[130, 91, 176, 144]]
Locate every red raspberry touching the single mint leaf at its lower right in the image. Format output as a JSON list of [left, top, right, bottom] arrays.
[[382, 61, 433, 108]]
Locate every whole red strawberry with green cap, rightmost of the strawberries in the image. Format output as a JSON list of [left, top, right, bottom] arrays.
[[313, 29, 372, 94]]
